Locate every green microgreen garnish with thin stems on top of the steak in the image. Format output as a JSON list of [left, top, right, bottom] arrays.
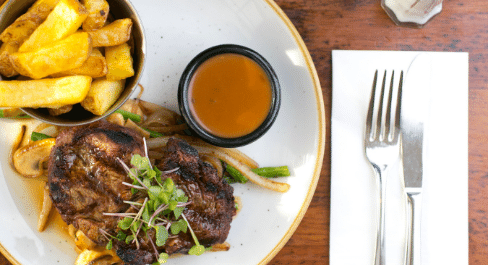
[[101, 141, 205, 265]]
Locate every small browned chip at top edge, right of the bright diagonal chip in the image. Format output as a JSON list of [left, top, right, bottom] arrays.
[[81, 0, 109, 31]]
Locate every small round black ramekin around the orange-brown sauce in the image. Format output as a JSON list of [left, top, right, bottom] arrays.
[[178, 44, 281, 147]]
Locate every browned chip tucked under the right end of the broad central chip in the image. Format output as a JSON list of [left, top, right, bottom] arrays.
[[50, 48, 108, 78]]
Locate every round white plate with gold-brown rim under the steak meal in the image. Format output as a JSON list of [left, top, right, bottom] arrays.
[[0, 0, 325, 265]]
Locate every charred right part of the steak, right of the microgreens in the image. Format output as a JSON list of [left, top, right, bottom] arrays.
[[152, 139, 236, 254]]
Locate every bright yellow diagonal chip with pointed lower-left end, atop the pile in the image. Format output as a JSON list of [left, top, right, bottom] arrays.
[[19, 0, 88, 52]]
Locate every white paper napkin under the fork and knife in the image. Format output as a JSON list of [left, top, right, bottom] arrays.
[[330, 51, 468, 265]]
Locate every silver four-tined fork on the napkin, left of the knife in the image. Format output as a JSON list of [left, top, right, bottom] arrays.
[[364, 70, 403, 265]]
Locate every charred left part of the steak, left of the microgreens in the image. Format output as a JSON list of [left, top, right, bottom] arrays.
[[48, 121, 144, 245]]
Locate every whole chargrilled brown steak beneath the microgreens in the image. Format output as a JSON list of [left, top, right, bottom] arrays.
[[48, 121, 236, 265]]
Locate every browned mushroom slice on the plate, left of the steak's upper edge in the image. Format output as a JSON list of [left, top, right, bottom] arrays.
[[12, 138, 56, 177]]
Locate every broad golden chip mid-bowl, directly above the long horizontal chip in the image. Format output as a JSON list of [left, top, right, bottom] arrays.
[[10, 32, 92, 79]]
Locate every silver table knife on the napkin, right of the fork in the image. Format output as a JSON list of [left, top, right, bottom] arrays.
[[400, 53, 431, 265]]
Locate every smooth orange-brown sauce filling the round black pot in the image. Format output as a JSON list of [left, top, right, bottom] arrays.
[[189, 53, 272, 138]]
